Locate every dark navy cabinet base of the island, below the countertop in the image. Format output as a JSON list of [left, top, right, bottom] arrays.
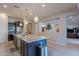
[[14, 37, 48, 56]]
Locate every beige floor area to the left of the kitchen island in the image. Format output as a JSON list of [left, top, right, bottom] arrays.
[[0, 41, 19, 56]]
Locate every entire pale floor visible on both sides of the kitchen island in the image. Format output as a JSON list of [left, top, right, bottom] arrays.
[[0, 41, 79, 56]]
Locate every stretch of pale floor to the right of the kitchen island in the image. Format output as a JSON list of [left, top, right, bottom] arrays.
[[48, 39, 79, 56]]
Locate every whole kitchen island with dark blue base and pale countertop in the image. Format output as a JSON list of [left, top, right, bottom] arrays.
[[14, 35, 48, 56]]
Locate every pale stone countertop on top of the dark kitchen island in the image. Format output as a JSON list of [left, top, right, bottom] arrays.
[[16, 34, 46, 42]]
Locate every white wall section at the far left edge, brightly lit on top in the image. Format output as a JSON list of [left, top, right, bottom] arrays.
[[0, 14, 8, 43]]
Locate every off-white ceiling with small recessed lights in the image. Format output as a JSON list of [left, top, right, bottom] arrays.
[[0, 3, 77, 20]]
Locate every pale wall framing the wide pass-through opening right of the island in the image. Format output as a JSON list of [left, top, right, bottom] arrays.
[[39, 10, 78, 43]]
